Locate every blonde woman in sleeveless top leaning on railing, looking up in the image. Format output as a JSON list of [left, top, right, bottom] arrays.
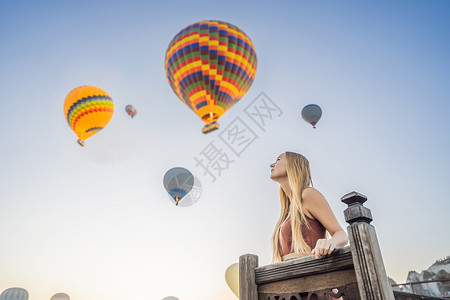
[[270, 152, 348, 299]]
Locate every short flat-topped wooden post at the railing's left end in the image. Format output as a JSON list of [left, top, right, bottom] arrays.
[[239, 254, 258, 300]]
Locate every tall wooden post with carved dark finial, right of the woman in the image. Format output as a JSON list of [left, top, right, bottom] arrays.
[[341, 192, 394, 300]]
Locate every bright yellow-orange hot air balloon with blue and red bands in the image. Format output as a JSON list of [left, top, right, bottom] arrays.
[[64, 85, 114, 146]]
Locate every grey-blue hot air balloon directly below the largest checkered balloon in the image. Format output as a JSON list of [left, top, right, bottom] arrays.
[[163, 167, 194, 205]]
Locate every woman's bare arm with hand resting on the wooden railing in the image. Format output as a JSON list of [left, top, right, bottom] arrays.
[[302, 188, 348, 258]]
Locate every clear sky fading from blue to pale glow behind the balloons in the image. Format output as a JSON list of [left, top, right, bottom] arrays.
[[0, 1, 450, 300]]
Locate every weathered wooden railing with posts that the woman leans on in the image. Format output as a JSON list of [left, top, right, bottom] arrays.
[[239, 192, 443, 300]]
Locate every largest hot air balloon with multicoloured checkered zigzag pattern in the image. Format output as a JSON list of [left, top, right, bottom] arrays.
[[165, 21, 257, 133]]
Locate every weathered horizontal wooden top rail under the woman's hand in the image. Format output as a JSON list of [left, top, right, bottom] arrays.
[[255, 247, 353, 285]]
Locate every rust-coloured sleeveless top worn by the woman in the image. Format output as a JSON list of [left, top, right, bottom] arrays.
[[281, 215, 326, 256]]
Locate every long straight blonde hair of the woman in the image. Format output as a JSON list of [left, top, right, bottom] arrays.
[[272, 152, 313, 262]]
